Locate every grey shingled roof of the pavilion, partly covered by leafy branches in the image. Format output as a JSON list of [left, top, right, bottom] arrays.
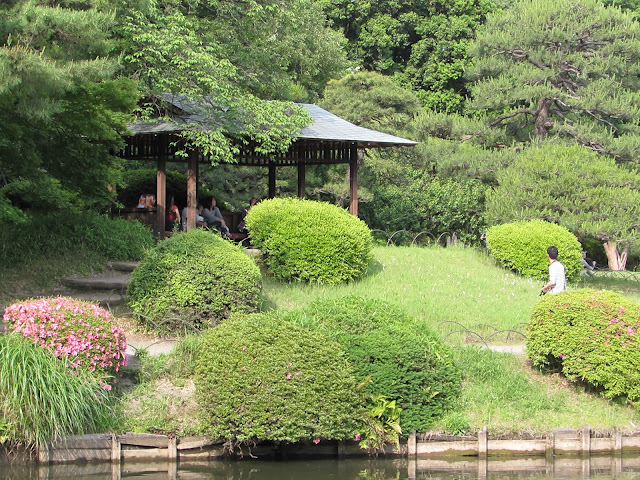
[[128, 94, 418, 147]]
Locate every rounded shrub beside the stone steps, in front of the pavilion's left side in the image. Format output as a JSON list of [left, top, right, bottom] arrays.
[[127, 229, 262, 333]]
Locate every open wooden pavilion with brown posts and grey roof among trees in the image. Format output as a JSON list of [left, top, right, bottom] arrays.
[[119, 94, 417, 237]]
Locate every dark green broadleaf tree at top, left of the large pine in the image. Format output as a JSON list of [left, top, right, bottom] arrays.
[[323, 0, 494, 111]]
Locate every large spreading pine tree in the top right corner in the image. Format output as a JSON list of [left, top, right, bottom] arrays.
[[470, 0, 640, 161]]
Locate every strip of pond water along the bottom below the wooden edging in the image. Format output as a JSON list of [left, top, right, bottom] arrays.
[[0, 457, 640, 480]]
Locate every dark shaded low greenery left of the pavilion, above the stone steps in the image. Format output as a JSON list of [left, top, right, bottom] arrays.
[[0, 211, 154, 268]]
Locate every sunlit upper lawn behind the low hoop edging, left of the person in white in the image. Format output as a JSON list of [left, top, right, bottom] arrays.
[[264, 247, 544, 343]]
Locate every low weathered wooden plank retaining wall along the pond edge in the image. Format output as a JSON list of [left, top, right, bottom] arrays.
[[23, 426, 640, 465]]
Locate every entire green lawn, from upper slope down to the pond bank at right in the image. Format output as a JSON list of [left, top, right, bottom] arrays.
[[263, 247, 640, 434]]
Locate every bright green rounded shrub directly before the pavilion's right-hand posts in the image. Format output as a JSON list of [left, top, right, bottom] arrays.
[[246, 198, 373, 284]]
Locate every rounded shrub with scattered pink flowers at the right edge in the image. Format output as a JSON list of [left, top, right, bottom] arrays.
[[527, 289, 640, 400]]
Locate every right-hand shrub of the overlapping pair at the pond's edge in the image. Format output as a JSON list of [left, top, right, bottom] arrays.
[[288, 296, 462, 434]]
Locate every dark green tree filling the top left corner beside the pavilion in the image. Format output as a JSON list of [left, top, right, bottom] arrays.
[[0, 1, 138, 221]]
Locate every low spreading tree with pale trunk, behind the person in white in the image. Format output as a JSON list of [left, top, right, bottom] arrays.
[[486, 145, 640, 270]]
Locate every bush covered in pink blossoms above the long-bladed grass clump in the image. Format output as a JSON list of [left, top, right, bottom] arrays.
[[2, 297, 127, 382]]
